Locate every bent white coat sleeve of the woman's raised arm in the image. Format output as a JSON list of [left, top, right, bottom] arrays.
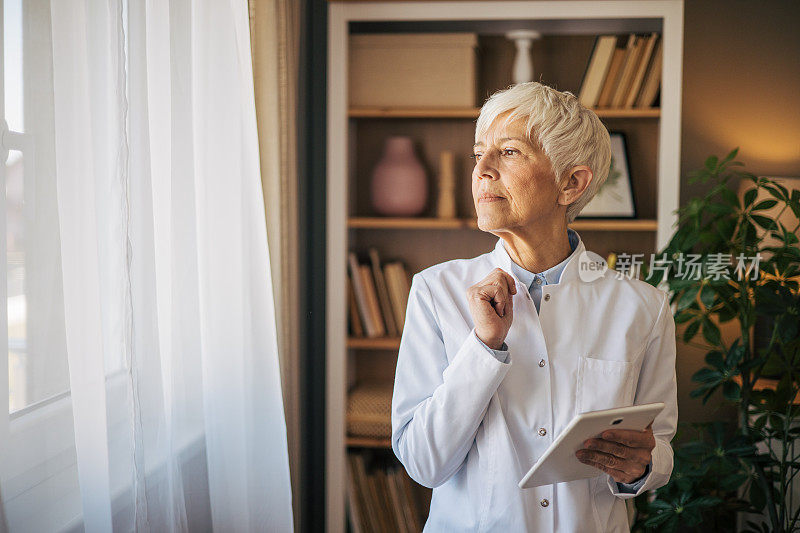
[[392, 273, 511, 488]]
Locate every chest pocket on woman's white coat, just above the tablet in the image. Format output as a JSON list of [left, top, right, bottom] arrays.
[[576, 355, 636, 413]]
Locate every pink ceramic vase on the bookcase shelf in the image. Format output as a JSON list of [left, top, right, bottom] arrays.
[[371, 137, 428, 217]]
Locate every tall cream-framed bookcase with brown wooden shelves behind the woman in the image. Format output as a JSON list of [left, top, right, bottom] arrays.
[[325, 0, 684, 533]]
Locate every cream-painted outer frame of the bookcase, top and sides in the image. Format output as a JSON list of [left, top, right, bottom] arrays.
[[325, 0, 684, 533]]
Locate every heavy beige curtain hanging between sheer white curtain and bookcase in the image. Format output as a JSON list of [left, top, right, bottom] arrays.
[[249, 0, 303, 529]]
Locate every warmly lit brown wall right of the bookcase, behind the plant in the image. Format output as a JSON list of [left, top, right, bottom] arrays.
[[678, 0, 800, 421]]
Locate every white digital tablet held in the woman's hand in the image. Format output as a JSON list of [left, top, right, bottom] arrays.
[[519, 403, 664, 489]]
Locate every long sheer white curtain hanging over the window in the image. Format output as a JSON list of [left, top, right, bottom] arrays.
[[0, 0, 292, 532]]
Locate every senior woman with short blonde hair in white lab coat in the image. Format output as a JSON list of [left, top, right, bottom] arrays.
[[392, 82, 677, 533]]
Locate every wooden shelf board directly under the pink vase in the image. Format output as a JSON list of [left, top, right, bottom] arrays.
[[347, 217, 658, 232]]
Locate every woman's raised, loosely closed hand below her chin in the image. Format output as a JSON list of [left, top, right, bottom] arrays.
[[467, 268, 517, 350]]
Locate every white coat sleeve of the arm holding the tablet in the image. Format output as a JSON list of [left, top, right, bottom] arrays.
[[607, 293, 678, 499]]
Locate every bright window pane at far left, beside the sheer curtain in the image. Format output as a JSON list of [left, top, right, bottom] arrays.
[[0, 0, 69, 414]]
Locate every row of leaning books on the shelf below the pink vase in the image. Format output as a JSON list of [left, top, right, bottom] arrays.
[[347, 248, 411, 338]]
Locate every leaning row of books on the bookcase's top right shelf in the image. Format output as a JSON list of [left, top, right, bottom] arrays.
[[578, 33, 663, 109]]
